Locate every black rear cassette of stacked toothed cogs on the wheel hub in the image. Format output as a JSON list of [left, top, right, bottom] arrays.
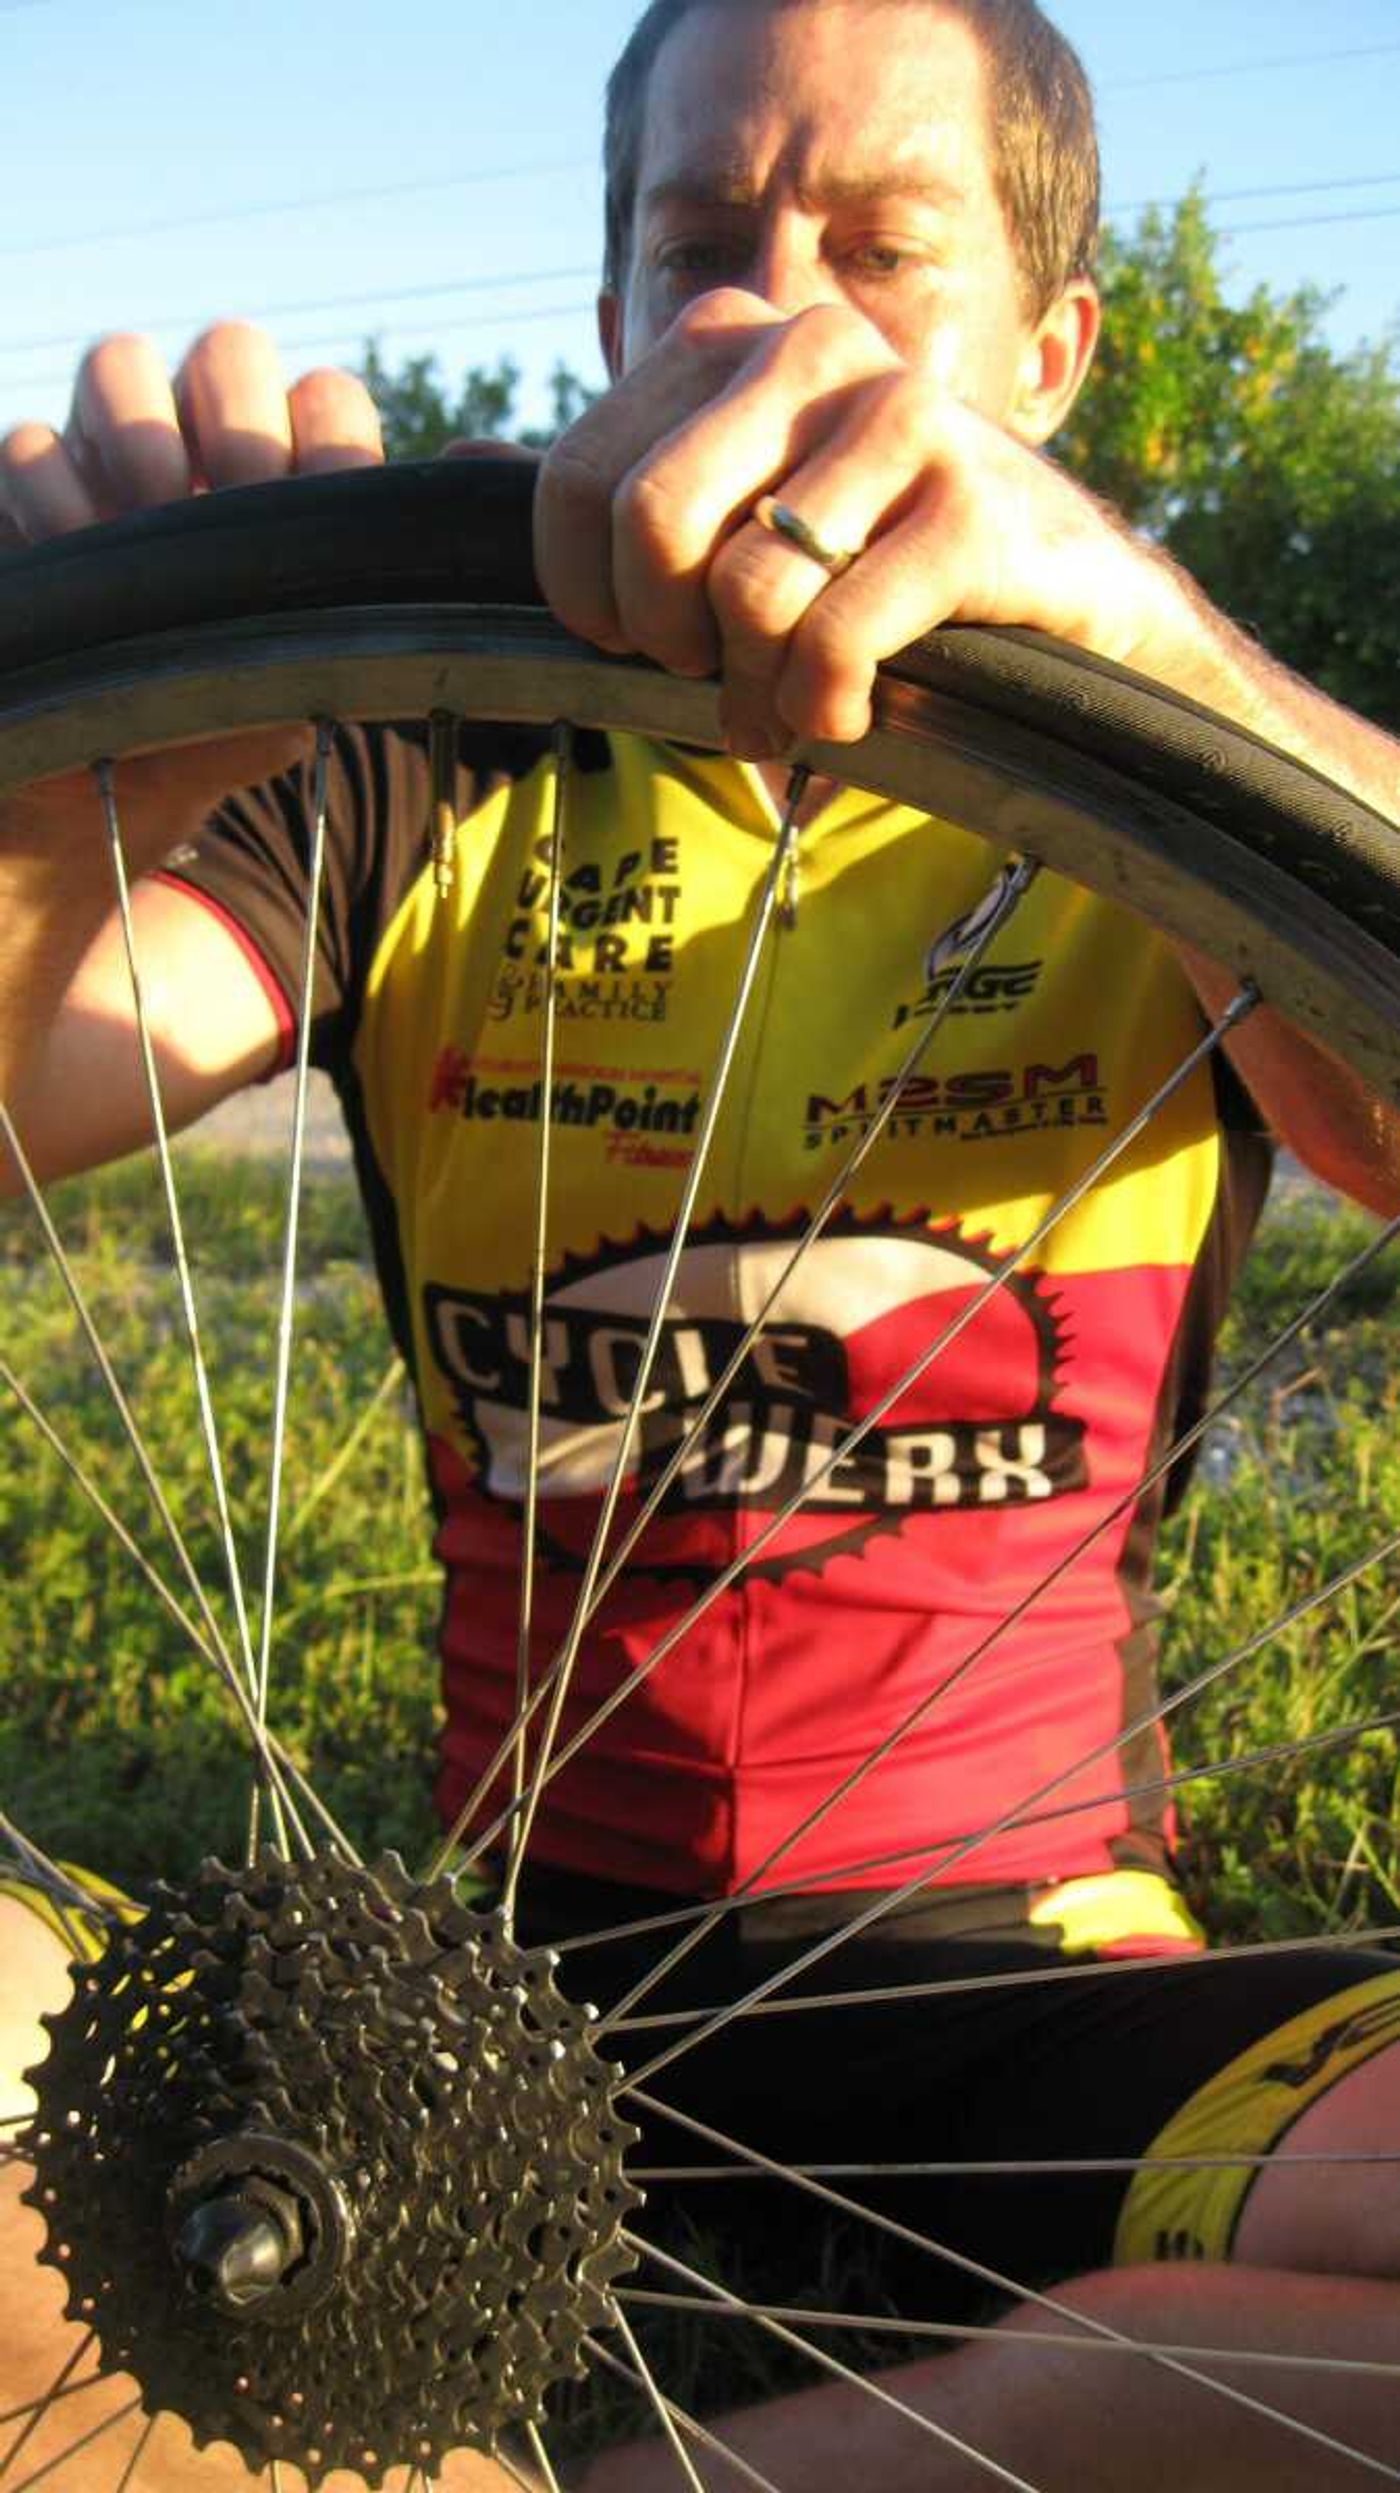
[[27, 1855, 640, 2486]]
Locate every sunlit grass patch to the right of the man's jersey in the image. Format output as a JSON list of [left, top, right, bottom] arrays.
[[1163, 1194, 1400, 1940]]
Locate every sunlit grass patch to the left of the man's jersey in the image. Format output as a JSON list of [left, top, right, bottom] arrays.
[[0, 1149, 436, 1880]]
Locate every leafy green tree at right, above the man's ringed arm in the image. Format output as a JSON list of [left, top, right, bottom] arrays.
[[1059, 192, 1400, 728]]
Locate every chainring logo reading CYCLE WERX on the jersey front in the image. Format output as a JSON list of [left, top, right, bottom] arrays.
[[423, 1214, 1086, 1578]]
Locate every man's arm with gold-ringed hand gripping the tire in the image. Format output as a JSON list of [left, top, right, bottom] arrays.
[[536, 292, 1400, 1212]]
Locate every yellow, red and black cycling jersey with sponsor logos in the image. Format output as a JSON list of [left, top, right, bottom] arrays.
[[169, 730, 1268, 1952]]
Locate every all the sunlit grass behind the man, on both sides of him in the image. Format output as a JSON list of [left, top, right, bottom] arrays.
[[0, 1147, 1400, 1937]]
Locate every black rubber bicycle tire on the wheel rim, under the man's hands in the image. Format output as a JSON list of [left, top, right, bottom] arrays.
[[0, 459, 1400, 945]]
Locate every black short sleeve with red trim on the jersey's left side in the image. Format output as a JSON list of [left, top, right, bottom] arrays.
[[162, 723, 548, 1074]]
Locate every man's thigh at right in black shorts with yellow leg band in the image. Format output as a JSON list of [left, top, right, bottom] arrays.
[[610, 1942, 1400, 2318]]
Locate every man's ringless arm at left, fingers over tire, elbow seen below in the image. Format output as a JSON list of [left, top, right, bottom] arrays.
[[0, 324, 381, 1192]]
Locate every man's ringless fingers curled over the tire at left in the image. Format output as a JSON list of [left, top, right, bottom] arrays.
[[0, 322, 384, 548]]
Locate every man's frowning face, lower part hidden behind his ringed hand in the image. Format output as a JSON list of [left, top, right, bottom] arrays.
[[610, 0, 1036, 421]]
